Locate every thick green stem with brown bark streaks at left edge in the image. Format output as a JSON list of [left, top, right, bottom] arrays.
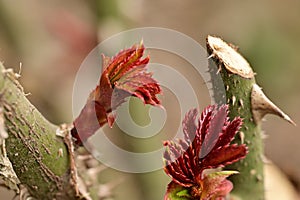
[[0, 63, 76, 199]]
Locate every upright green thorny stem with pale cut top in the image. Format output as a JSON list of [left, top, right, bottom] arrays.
[[207, 36, 264, 200]]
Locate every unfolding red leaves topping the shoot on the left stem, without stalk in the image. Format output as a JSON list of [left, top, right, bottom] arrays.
[[98, 44, 161, 109]]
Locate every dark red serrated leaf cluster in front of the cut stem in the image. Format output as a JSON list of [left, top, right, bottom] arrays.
[[164, 105, 247, 200]]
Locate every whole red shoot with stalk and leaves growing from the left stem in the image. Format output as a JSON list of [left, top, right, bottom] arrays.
[[71, 44, 161, 144]]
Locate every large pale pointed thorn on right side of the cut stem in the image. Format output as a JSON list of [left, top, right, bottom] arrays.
[[251, 84, 296, 126]]
